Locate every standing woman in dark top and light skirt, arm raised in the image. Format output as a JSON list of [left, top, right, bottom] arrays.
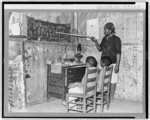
[[90, 22, 121, 100]]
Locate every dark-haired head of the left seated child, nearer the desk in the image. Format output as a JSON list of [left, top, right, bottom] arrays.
[[86, 56, 97, 68]]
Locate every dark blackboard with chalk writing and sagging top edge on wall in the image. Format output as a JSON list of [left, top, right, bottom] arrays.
[[27, 17, 71, 42]]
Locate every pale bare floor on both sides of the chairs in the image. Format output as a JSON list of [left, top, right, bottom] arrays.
[[19, 99, 143, 113]]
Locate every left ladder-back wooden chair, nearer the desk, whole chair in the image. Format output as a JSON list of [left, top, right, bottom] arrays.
[[66, 67, 97, 113]]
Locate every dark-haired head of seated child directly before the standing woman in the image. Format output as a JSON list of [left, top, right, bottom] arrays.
[[101, 56, 112, 67]]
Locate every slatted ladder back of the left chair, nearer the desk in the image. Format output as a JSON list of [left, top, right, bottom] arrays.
[[84, 67, 98, 96]]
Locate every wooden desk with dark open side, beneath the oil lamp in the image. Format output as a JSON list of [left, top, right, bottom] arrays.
[[47, 64, 85, 101]]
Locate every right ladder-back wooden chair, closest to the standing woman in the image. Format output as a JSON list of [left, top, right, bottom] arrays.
[[96, 65, 113, 112]]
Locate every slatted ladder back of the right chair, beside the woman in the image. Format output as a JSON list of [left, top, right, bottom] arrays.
[[101, 65, 113, 92]]
